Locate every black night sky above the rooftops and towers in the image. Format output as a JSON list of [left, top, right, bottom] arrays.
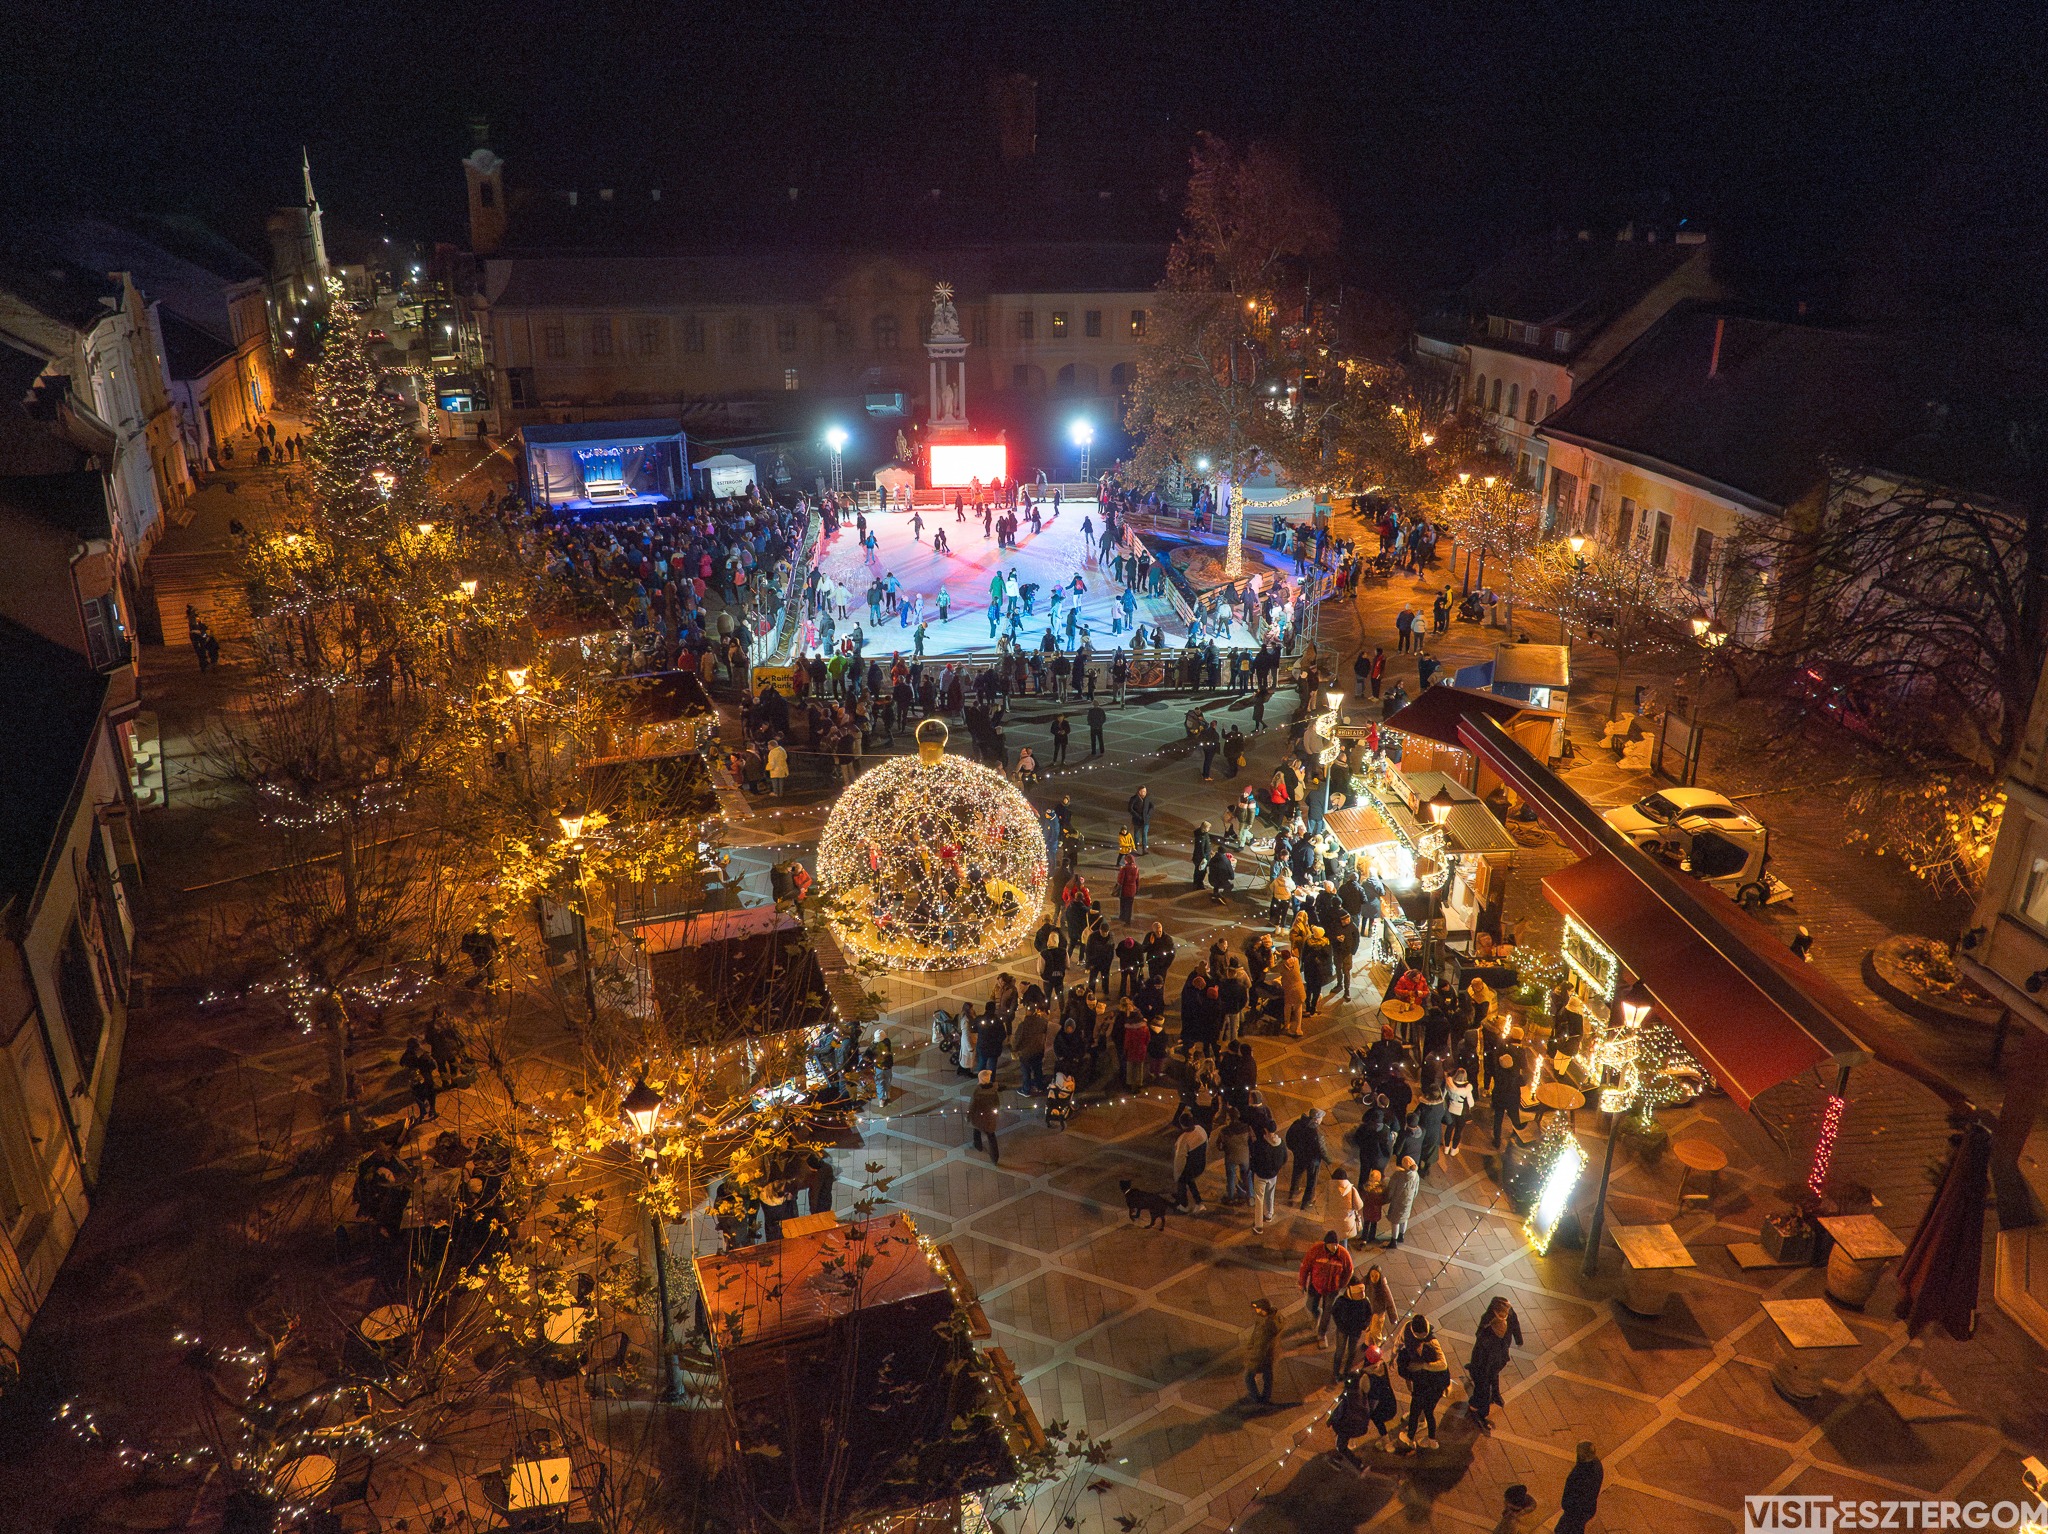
[[0, 0, 2048, 319]]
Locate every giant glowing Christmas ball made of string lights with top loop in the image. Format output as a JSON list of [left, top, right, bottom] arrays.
[[817, 719, 1044, 969]]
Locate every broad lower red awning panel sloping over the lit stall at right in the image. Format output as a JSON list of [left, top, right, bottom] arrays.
[[1542, 852, 1858, 1108]]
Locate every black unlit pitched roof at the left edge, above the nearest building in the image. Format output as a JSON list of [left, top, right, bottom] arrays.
[[0, 619, 106, 899]]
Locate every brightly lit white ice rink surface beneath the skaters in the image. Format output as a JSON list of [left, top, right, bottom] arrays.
[[802, 502, 1294, 657]]
